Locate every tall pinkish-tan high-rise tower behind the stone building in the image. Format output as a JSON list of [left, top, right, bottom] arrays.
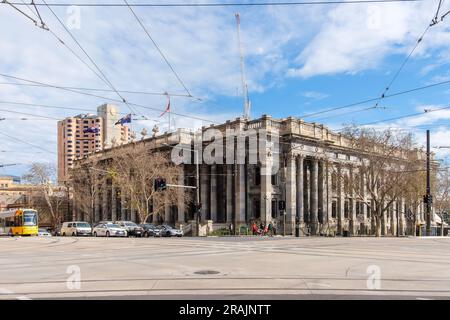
[[58, 104, 129, 183]]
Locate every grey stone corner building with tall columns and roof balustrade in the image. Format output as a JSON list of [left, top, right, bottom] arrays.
[[74, 115, 436, 235]]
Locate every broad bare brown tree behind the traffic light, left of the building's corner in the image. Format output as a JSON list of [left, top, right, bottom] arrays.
[[108, 144, 186, 222]]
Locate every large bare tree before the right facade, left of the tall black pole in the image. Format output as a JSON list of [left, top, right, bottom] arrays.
[[341, 126, 423, 237]]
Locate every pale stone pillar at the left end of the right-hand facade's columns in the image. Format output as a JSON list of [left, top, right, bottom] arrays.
[[286, 154, 297, 234]]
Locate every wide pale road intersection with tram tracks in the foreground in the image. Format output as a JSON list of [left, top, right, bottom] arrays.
[[0, 237, 450, 299]]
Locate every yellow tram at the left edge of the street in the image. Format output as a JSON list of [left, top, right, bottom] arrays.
[[0, 209, 38, 236]]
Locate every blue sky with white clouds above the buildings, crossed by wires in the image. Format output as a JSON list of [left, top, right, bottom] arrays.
[[0, 0, 450, 175]]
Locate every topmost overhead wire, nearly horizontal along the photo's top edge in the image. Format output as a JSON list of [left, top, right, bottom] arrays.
[[3, 0, 425, 8]]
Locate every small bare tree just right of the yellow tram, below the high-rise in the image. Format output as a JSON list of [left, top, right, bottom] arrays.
[[23, 163, 68, 227]]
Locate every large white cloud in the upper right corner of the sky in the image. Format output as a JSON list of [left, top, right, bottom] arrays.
[[288, 1, 450, 77]]
